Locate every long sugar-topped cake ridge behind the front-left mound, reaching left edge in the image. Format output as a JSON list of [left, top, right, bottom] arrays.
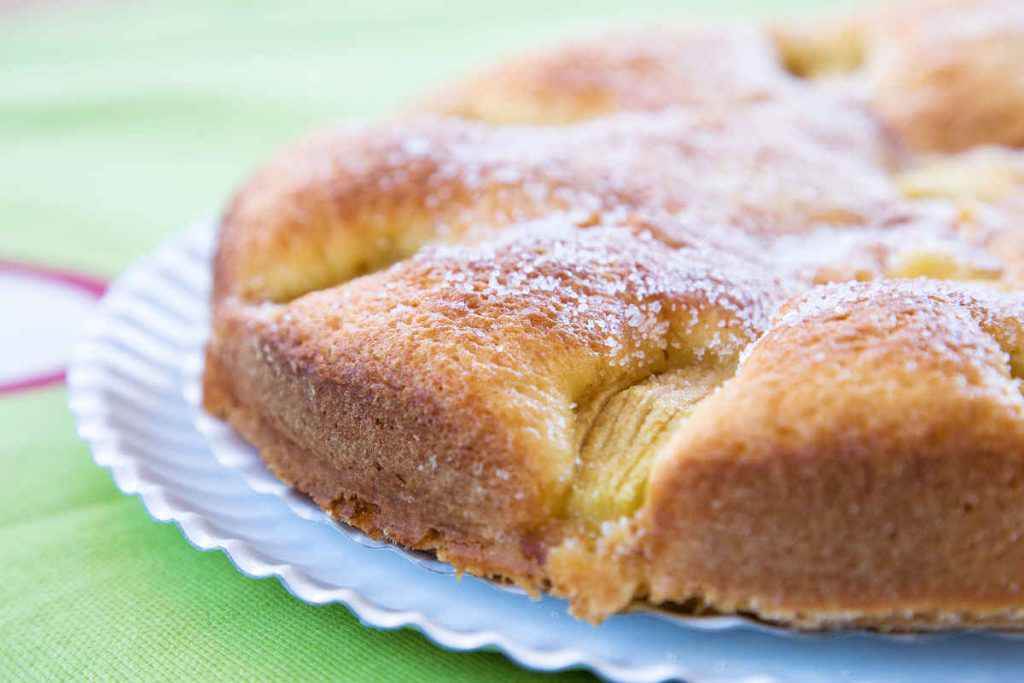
[[214, 99, 905, 301]]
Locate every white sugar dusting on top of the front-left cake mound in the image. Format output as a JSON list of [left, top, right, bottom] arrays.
[[405, 217, 793, 365]]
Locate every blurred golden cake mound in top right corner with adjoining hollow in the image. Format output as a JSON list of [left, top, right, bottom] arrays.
[[776, 0, 1024, 152]]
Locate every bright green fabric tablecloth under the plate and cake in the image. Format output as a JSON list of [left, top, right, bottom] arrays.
[[0, 0, 847, 680]]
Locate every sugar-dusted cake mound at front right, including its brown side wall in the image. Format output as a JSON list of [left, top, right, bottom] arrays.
[[647, 282, 1024, 626]]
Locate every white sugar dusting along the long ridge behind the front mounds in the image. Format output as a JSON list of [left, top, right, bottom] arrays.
[[326, 95, 898, 249]]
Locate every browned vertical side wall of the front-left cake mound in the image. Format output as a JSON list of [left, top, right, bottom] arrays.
[[203, 304, 557, 594]]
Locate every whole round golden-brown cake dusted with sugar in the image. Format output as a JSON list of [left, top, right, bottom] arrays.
[[204, 0, 1024, 630]]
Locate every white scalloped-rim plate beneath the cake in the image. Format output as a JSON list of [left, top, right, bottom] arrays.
[[69, 224, 1024, 683]]
